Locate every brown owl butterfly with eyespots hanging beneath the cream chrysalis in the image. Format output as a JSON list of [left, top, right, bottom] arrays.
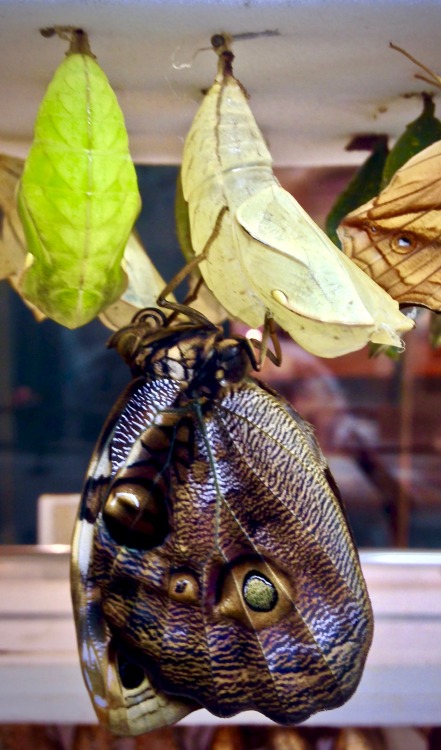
[[71, 309, 372, 734]]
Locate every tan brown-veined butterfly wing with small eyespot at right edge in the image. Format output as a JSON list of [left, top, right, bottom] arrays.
[[338, 47, 441, 312]]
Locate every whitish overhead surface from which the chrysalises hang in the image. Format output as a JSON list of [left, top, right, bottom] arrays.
[[0, 0, 441, 166]]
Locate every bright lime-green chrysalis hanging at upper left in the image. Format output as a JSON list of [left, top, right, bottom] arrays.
[[18, 29, 140, 328]]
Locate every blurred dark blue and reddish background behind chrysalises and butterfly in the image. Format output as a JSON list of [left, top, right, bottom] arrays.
[[0, 166, 441, 548]]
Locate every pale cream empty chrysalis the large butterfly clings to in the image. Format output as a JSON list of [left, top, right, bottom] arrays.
[[182, 34, 414, 357]]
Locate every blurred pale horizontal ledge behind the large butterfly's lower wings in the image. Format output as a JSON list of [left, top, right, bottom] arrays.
[[0, 547, 441, 726]]
